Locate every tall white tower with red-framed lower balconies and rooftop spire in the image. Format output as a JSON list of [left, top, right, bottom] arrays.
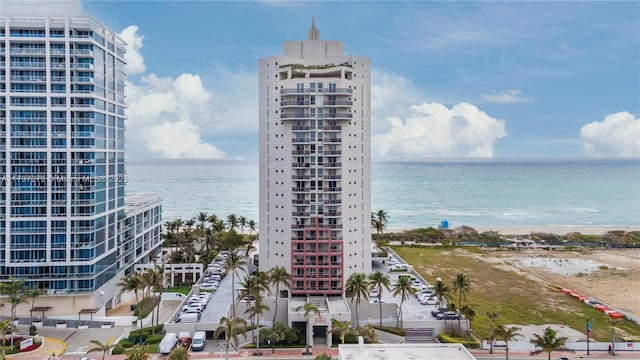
[[259, 18, 371, 296]]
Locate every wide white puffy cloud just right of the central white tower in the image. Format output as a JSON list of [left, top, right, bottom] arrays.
[[372, 103, 507, 157]]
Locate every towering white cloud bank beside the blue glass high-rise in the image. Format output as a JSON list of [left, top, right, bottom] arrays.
[[121, 25, 225, 158]]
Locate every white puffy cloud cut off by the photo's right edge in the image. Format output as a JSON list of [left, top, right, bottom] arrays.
[[580, 111, 640, 158]]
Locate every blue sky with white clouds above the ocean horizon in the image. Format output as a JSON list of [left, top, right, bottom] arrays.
[[3, 0, 640, 158]]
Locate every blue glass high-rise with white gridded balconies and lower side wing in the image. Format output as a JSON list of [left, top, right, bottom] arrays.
[[0, 5, 161, 311]]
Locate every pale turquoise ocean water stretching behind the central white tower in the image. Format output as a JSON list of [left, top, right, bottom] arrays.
[[127, 160, 640, 229]]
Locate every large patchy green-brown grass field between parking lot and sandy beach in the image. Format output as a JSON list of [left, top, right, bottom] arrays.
[[393, 246, 640, 341]]
